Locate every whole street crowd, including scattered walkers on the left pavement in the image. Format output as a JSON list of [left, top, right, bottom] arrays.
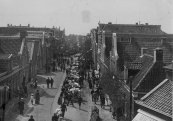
[[14, 54, 108, 121]]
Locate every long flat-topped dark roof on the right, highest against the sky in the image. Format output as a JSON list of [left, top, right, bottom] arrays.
[[99, 23, 164, 34]]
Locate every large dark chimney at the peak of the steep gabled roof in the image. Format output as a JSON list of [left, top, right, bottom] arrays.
[[154, 48, 163, 62]]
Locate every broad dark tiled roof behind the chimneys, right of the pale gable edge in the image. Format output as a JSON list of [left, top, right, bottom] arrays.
[[117, 36, 173, 69]]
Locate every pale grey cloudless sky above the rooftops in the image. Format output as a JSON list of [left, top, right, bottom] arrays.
[[0, 0, 173, 35]]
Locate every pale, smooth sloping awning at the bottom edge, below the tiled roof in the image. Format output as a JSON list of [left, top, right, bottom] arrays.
[[132, 109, 166, 121]]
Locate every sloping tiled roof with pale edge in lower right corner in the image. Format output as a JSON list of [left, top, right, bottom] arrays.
[[137, 79, 173, 117]]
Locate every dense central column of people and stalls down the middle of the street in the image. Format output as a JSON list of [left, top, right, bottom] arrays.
[[52, 56, 83, 121]]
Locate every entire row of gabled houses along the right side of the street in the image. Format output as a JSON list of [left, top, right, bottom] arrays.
[[90, 22, 173, 121]]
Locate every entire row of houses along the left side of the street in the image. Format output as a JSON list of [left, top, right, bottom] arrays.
[[0, 25, 65, 118]]
